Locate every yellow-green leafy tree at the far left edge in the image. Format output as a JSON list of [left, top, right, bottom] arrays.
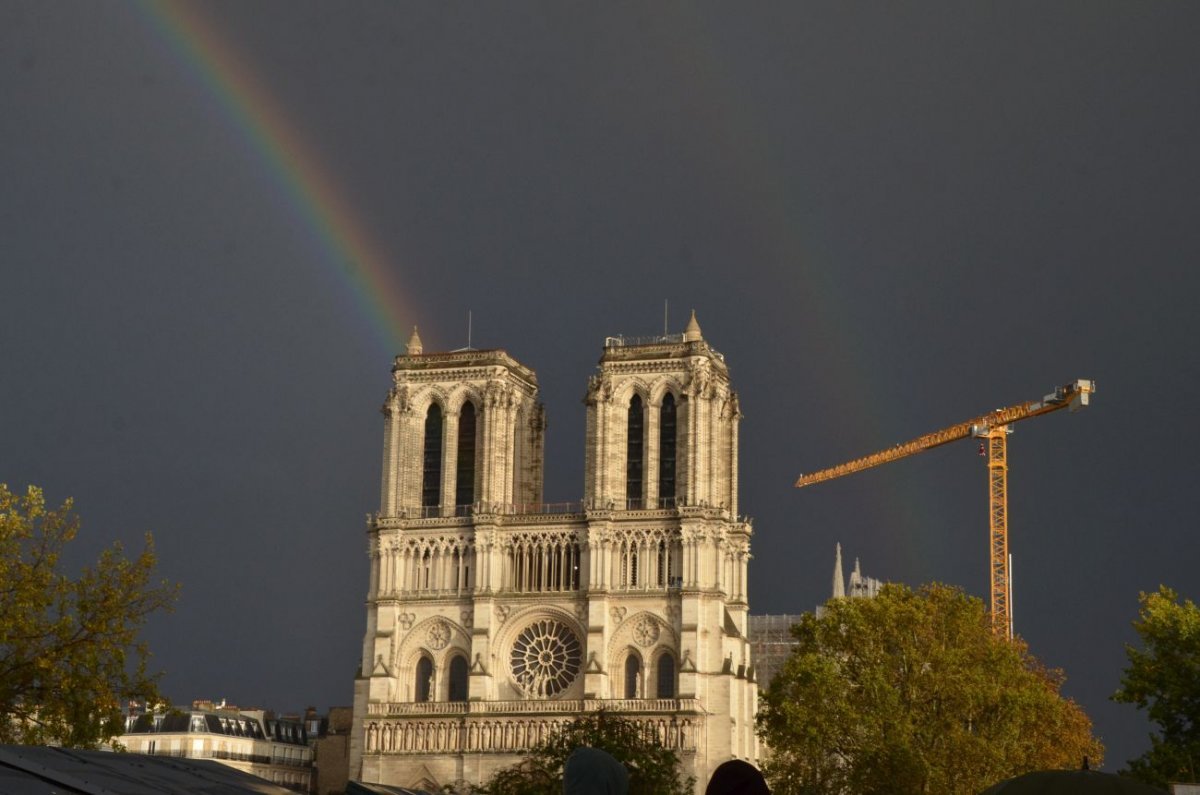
[[0, 484, 176, 747]]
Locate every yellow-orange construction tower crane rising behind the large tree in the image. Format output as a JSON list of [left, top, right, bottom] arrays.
[[796, 381, 1096, 638]]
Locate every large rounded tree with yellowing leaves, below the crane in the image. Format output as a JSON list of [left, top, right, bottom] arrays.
[[758, 585, 1103, 795]]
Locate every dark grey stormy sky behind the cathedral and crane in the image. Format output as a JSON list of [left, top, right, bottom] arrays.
[[0, 0, 1200, 769]]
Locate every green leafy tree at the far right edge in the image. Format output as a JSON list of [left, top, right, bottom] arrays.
[[1112, 585, 1200, 789]]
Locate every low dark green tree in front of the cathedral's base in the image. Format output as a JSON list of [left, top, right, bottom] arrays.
[[475, 710, 695, 795]]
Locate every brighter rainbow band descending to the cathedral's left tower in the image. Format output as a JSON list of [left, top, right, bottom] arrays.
[[139, 0, 413, 355]]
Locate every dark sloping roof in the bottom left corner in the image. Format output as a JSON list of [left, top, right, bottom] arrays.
[[0, 746, 293, 795]]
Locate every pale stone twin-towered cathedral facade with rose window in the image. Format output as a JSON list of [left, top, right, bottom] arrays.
[[350, 317, 757, 791]]
